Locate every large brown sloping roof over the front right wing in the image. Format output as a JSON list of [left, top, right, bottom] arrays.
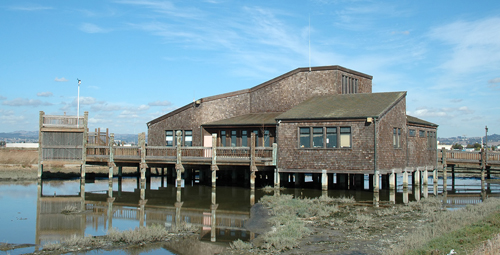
[[276, 92, 406, 120]]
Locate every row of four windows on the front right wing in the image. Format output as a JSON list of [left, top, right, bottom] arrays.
[[299, 127, 351, 149]]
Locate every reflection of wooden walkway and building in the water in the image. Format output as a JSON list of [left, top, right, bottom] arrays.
[[36, 178, 255, 245]]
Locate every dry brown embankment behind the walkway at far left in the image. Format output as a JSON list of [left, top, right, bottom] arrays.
[[0, 148, 130, 181]]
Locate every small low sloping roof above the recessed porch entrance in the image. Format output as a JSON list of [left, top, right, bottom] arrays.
[[203, 112, 282, 127]]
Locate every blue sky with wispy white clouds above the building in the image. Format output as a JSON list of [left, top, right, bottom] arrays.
[[0, 0, 500, 137]]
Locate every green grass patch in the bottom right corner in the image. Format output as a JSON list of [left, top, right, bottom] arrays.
[[390, 199, 500, 254]]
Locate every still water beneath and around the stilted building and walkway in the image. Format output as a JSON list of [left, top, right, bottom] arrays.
[[0, 176, 500, 254]]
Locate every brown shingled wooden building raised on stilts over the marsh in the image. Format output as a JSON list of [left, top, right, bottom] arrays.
[[147, 66, 437, 189]]
